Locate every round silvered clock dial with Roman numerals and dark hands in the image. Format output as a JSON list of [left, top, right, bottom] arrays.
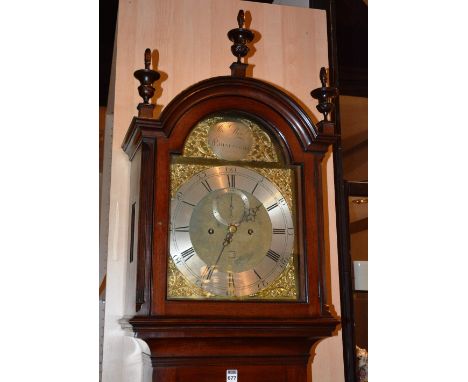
[[170, 166, 294, 298]]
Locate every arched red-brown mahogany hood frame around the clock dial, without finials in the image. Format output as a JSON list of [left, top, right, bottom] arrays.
[[122, 77, 336, 326]]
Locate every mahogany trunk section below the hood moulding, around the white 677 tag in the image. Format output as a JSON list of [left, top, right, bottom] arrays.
[[149, 338, 311, 382]]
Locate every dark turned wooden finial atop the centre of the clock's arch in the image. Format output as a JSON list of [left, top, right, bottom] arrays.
[[228, 9, 255, 77]]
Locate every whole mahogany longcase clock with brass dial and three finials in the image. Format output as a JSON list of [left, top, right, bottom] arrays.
[[122, 11, 339, 382]]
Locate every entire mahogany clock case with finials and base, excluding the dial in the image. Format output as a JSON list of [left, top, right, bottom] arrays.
[[121, 12, 339, 382]]
